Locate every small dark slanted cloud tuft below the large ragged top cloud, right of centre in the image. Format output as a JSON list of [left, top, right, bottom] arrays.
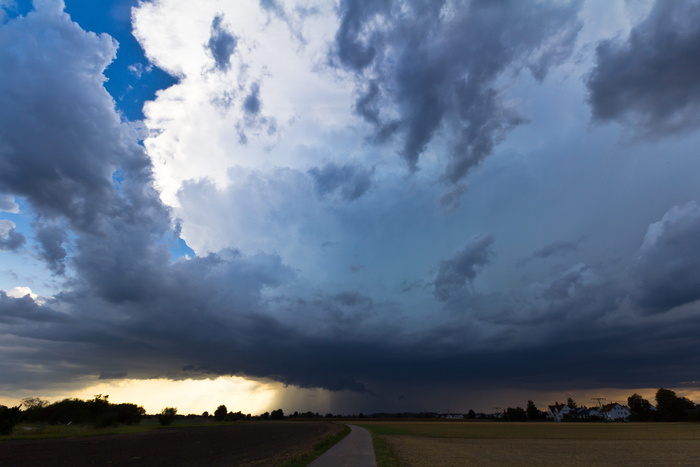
[[433, 235, 494, 301]]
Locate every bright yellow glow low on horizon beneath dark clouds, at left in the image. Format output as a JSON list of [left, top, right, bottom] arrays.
[[0, 376, 278, 415]]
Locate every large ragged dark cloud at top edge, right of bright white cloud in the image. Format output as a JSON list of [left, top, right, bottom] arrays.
[[330, 1, 581, 184]]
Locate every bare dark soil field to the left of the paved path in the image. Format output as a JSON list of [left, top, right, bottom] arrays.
[[0, 422, 342, 467]]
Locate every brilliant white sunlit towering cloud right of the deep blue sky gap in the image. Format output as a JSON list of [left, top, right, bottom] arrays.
[[134, 0, 354, 206]]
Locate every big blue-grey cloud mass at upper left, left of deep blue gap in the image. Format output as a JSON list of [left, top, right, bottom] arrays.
[[0, 5, 159, 236]]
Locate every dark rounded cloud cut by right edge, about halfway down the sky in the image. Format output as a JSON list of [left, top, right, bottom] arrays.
[[635, 202, 700, 312]]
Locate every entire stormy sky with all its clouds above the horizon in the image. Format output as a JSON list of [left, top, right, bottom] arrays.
[[0, 0, 700, 413]]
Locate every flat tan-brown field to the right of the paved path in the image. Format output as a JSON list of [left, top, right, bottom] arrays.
[[358, 421, 700, 467]]
